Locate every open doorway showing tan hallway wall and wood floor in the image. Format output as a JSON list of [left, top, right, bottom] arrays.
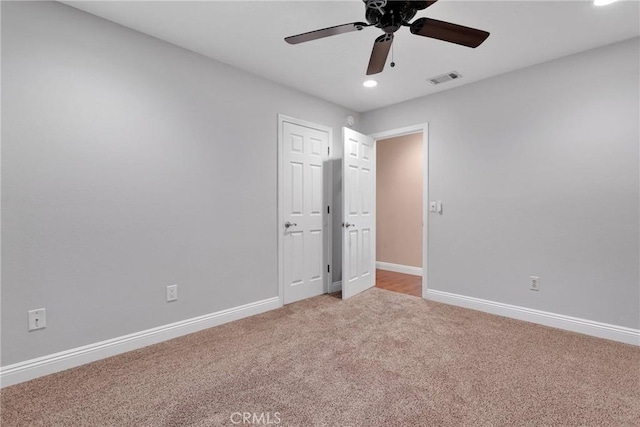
[[372, 123, 429, 297]]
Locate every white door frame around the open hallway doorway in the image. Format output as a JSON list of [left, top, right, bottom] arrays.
[[369, 123, 429, 298]]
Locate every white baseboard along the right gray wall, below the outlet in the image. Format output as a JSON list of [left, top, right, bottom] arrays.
[[426, 289, 640, 346]]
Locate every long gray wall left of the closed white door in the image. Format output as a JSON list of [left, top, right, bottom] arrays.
[[1, 2, 359, 365]]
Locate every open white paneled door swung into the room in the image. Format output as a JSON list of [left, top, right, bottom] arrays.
[[342, 128, 376, 298]]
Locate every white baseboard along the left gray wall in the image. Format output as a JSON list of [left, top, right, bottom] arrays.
[[0, 297, 282, 387]]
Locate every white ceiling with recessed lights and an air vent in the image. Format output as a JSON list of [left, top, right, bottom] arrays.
[[64, 0, 640, 112]]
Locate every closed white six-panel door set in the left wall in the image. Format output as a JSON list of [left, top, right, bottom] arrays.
[[279, 119, 331, 304]]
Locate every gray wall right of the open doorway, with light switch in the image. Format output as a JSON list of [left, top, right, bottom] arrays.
[[362, 39, 640, 328]]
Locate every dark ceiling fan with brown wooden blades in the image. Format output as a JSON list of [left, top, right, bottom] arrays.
[[284, 0, 489, 75]]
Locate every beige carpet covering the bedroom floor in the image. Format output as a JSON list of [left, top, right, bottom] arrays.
[[1, 288, 640, 427]]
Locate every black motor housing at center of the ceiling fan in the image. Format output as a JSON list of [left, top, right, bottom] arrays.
[[362, 0, 434, 34]]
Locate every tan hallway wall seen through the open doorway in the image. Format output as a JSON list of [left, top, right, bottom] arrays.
[[376, 133, 423, 267]]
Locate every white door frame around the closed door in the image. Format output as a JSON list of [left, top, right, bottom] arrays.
[[276, 114, 334, 307]]
